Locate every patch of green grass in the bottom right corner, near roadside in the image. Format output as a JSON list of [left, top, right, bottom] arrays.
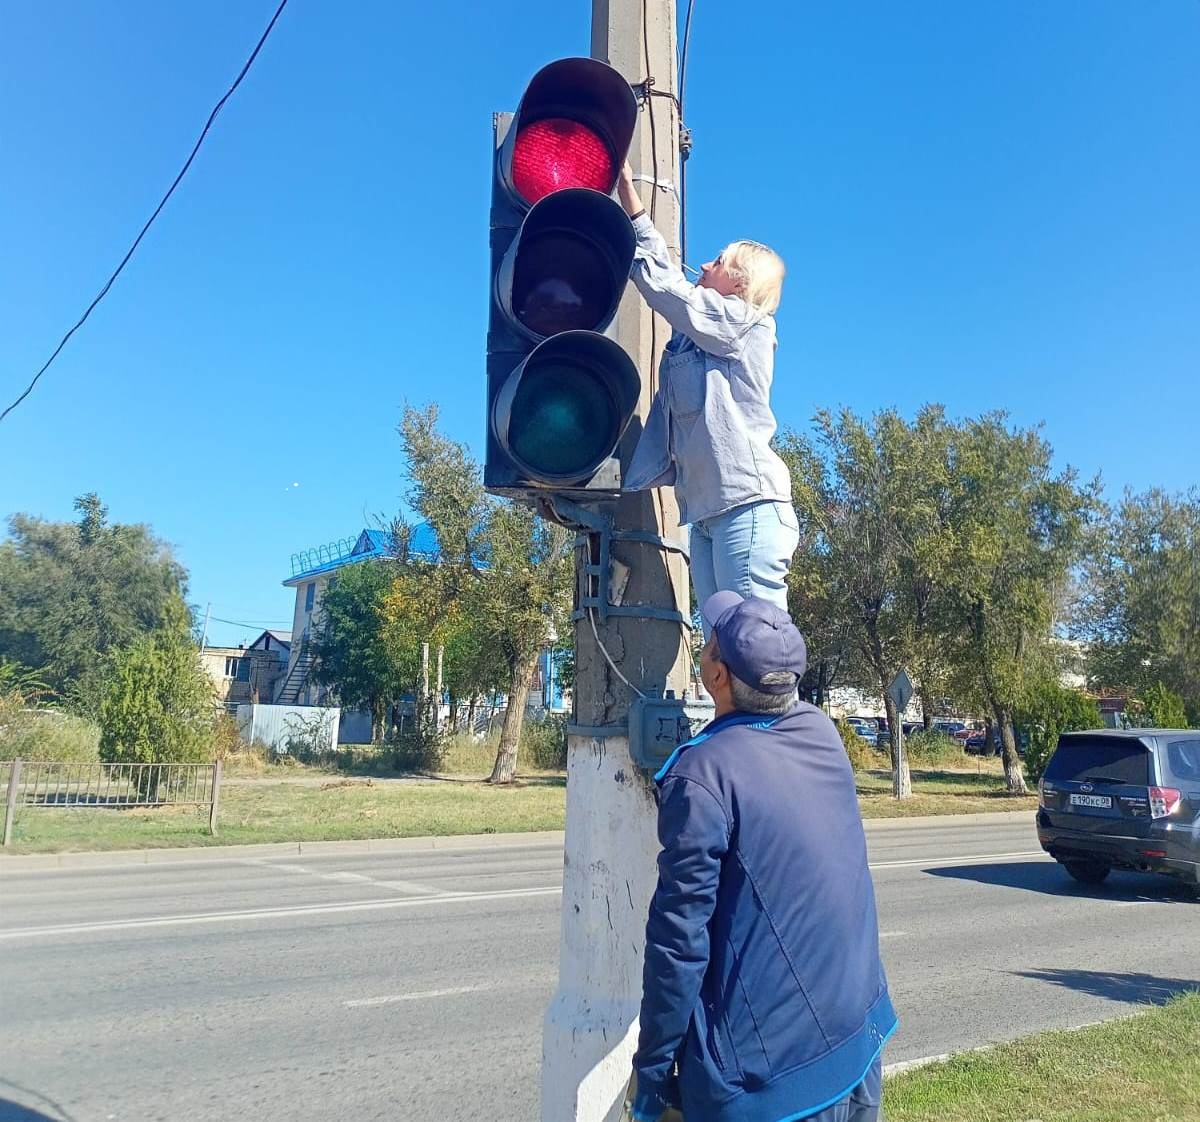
[[883, 991, 1200, 1122]]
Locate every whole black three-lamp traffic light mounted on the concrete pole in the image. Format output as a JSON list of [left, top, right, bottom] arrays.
[[484, 59, 640, 497]]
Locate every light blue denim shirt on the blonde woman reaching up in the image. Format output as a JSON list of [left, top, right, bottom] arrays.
[[624, 215, 792, 526]]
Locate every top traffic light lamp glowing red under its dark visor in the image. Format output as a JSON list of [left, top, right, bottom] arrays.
[[500, 59, 637, 206]]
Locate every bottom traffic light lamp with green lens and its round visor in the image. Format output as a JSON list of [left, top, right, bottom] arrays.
[[492, 331, 638, 485]]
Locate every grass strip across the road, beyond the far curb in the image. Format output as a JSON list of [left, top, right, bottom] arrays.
[[0, 767, 1037, 853]]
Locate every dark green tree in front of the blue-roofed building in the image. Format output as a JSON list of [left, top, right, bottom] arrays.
[[310, 558, 405, 742]]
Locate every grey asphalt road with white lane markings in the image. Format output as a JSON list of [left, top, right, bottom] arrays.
[[0, 816, 1200, 1122]]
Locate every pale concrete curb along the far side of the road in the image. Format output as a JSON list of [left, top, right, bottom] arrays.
[[0, 810, 1033, 875]]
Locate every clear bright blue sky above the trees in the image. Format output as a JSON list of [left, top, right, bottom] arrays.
[[0, 0, 1200, 642]]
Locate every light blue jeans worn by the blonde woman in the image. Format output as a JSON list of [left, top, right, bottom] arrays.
[[691, 499, 800, 642]]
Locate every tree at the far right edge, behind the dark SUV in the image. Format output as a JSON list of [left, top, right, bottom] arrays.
[[1074, 488, 1200, 720]]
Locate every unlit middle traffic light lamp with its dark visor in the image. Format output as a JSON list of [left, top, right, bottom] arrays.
[[496, 188, 636, 340]]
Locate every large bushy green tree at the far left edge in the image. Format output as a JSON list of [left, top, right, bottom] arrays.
[[0, 493, 191, 700]]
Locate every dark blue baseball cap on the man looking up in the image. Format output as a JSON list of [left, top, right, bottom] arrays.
[[701, 592, 809, 694]]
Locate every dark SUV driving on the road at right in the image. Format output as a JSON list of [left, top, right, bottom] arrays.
[[1038, 728, 1200, 888]]
